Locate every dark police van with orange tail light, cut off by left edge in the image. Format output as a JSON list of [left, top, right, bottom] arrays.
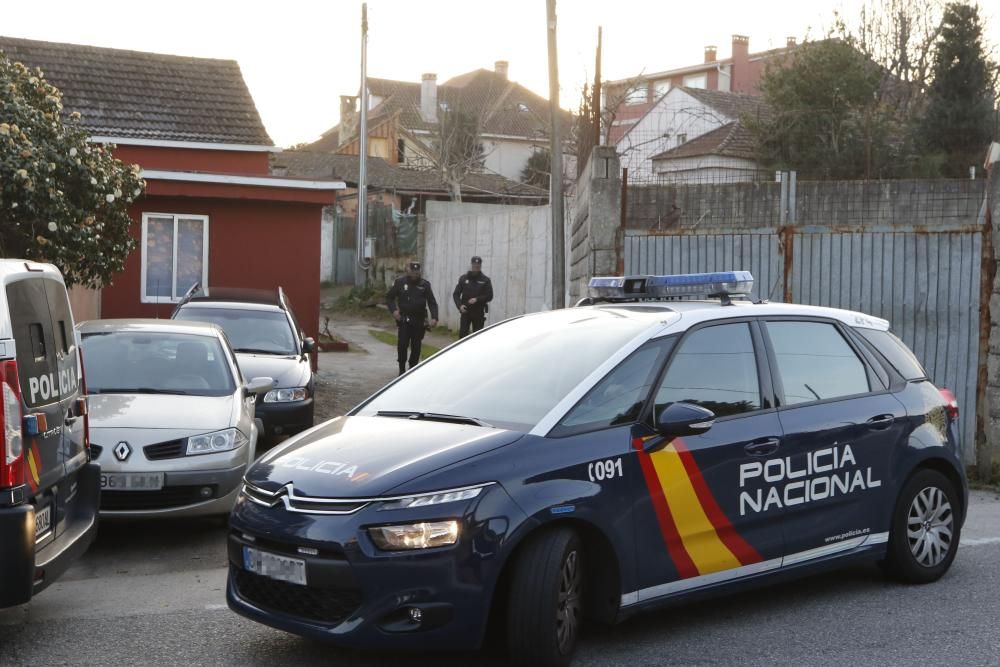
[[0, 259, 100, 608]]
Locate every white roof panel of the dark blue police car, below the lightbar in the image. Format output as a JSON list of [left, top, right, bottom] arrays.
[[575, 300, 889, 331]]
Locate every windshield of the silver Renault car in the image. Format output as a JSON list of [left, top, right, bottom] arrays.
[[81, 331, 236, 396]]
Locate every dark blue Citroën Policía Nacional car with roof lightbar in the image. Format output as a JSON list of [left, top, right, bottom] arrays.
[[227, 272, 968, 665]]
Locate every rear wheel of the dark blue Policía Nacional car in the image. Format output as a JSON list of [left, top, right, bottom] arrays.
[[884, 469, 961, 584]]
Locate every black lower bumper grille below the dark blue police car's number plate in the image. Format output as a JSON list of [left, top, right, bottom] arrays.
[[234, 568, 361, 626]]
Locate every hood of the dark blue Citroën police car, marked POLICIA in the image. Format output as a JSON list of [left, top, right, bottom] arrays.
[[246, 417, 524, 498]]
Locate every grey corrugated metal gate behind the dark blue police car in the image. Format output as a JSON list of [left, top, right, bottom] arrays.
[[622, 227, 982, 463]]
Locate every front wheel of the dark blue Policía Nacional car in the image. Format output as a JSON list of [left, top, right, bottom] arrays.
[[507, 528, 586, 667]]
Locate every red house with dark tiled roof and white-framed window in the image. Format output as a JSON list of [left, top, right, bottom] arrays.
[[0, 37, 344, 336]]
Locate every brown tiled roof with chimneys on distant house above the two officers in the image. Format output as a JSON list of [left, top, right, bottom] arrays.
[[309, 69, 573, 150]]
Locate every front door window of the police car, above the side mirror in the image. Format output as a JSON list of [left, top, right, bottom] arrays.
[[656, 322, 761, 417]]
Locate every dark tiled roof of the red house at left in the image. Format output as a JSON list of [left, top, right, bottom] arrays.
[[0, 37, 273, 145]]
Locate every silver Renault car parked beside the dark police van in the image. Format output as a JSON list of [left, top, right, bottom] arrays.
[[77, 320, 273, 517]]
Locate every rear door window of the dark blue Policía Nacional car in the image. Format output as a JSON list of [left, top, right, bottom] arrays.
[[767, 322, 871, 405]]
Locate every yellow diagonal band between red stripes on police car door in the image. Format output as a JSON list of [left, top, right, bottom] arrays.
[[650, 443, 740, 575]]
